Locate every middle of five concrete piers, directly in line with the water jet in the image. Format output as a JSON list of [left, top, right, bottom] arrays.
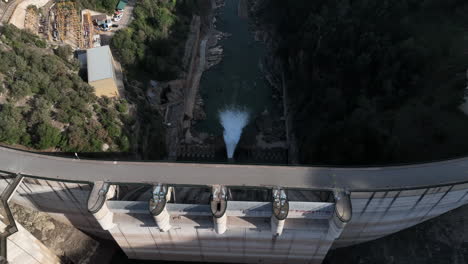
[[210, 185, 228, 234]]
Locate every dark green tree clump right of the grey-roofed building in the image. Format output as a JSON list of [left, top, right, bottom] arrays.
[[111, 0, 207, 80]]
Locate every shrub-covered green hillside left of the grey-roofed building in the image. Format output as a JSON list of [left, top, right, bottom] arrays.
[[0, 25, 130, 152]]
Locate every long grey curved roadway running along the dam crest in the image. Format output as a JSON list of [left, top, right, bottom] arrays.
[[0, 147, 468, 191]]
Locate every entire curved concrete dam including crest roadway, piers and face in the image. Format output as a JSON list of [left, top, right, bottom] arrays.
[[0, 147, 468, 263]]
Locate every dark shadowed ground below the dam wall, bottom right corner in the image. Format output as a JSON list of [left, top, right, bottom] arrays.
[[324, 206, 468, 264]]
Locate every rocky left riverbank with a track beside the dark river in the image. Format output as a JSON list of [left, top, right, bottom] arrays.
[[155, 0, 219, 160]]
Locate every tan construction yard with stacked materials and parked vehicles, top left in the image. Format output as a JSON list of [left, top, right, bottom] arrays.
[[6, 0, 135, 49]]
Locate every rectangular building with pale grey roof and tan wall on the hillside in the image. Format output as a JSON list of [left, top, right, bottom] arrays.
[[86, 46, 119, 97]]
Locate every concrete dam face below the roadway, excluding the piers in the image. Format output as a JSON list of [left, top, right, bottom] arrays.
[[0, 172, 468, 263]]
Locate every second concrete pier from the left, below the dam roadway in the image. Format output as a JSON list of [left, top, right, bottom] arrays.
[[149, 184, 172, 232]]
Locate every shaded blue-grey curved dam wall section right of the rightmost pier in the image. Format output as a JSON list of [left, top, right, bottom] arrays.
[[333, 184, 468, 247]]
